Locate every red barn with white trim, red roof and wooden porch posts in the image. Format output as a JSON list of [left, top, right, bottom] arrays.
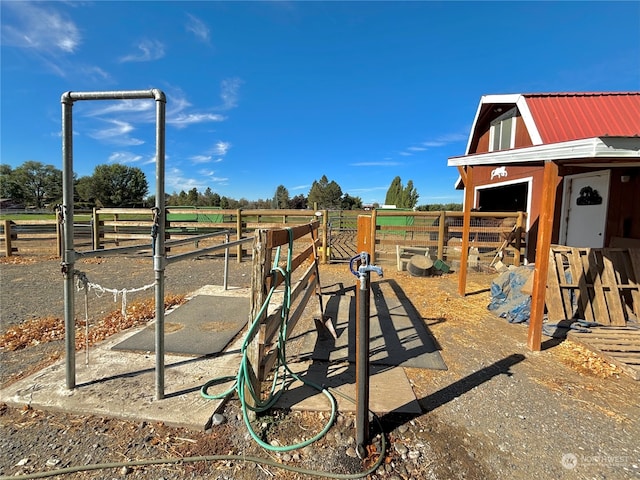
[[448, 92, 640, 350]]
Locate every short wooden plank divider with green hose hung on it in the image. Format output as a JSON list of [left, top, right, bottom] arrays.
[[245, 221, 324, 405]]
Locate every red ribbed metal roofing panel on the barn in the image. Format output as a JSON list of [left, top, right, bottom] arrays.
[[523, 92, 640, 144]]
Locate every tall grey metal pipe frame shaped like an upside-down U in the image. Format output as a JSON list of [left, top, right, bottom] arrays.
[[60, 89, 167, 400]]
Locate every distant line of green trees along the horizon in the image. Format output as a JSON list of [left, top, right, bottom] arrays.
[[0, 160, 462, 210]]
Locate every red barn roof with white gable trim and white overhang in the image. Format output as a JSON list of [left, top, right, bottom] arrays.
[[448, 92, 640, 166]]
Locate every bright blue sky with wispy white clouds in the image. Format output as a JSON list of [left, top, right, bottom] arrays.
[[0, 1, 640, 205]]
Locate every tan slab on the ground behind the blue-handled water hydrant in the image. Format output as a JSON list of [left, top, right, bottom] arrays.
[[276, 361, 422, 415]]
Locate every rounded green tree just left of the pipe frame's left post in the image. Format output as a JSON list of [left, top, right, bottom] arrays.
[[12, 161, 62, 208]]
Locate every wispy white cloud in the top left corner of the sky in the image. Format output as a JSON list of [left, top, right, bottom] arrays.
[[2, 2, 82, 53]]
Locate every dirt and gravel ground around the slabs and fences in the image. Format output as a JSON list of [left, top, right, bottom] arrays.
[[0, 251, 640, 479]]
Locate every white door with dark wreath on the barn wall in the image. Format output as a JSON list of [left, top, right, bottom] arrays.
[[560, 170, 609, 248]]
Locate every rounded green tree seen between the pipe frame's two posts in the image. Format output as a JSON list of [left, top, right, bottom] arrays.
[[93, 163, 149, 207]]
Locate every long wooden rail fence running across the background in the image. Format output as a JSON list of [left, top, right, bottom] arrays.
[[0, 207, 526, 266]]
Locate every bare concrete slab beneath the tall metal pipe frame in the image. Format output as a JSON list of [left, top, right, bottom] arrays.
[[0, 322, 241, 430]]
